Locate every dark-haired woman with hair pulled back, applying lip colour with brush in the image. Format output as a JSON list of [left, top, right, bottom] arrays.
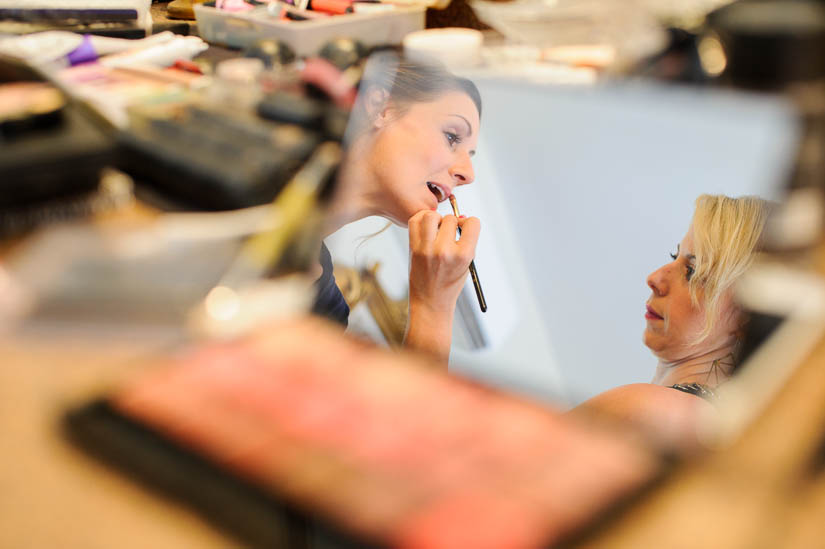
[[316, 54, 481, 365]]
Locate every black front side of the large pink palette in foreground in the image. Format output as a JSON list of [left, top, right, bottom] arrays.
[[63, 400, 378, 549]]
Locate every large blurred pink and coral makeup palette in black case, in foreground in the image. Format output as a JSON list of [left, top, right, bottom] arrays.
[[66, 319, 664, 548]]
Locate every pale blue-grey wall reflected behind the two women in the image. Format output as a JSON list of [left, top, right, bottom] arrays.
[[331, 81, 795, 403]]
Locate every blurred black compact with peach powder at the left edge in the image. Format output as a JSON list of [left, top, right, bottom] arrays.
[[0, 55, 125, 238]]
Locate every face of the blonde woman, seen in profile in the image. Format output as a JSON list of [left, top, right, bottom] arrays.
[[644, 227, 738, 361]]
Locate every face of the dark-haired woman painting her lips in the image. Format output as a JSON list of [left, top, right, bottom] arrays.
[[370, 91, 479, 226]]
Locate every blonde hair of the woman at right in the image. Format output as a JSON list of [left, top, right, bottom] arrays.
[[688, 194, 770, 341]]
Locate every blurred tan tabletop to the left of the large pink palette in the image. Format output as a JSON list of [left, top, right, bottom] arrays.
[[0, 326, 245, 549]]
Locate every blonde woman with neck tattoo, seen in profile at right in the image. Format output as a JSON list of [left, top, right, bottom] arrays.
[[579, 195, 768, 445]]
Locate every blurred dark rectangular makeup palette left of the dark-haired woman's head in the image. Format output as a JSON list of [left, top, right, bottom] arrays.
[[117, 105, 321, 210]]
